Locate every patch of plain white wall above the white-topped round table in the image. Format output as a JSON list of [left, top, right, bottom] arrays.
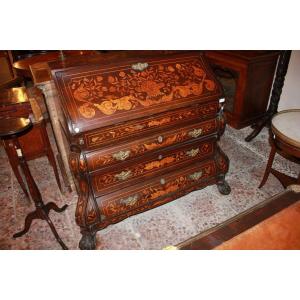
[[278, 50, 300, 111]]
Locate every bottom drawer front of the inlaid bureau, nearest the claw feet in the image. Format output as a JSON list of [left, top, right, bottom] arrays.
[[97, 161, 216, 220]]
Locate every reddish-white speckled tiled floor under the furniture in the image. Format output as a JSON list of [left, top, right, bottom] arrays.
[[0, 123, 299, 249]]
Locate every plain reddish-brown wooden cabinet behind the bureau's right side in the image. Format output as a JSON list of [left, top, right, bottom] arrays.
[[205, 50, 279, 129]]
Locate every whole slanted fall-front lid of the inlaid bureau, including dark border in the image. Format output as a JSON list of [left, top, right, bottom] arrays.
[[50, 53, 222, 134]]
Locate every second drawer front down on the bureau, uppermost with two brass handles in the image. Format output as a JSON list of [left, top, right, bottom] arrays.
[[86, 119, 218, 171]]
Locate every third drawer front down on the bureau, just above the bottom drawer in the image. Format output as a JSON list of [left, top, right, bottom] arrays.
[[92, 138, 216, 197]]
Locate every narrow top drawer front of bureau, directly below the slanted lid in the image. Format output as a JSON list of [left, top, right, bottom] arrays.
[[82, 102, 219, 149]]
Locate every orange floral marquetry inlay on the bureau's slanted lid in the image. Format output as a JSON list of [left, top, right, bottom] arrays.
[[69, 59, 216, 119]]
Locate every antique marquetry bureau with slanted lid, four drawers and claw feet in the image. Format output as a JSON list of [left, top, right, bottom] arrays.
[[49, 52, 230, 249]]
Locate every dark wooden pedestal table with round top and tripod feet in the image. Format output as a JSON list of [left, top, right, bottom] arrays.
[[0, 117, 68, 250]]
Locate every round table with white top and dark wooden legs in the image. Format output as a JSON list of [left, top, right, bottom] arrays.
[[259, 109, 300, 188]]
